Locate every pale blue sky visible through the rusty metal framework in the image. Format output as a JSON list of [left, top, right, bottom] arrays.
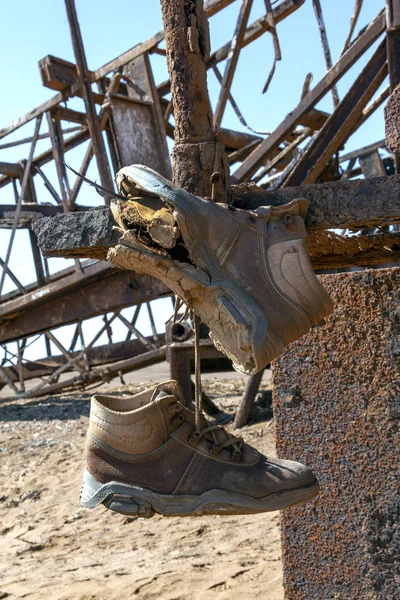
[[0, 0, 387, 360]]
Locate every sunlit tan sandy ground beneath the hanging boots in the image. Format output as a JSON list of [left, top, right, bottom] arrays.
[[0, 374, 283, 600]]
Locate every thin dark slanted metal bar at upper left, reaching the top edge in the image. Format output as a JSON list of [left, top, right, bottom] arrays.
[[65, 0, 114, 190]]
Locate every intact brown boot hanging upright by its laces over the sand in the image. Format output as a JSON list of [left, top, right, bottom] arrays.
[[81, 381, 318, 517]]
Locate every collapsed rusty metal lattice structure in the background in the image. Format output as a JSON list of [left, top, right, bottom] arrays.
[[0, 0, 399, 404]]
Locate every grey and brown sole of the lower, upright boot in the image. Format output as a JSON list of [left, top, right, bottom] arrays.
[[81, 469, 319, 518]]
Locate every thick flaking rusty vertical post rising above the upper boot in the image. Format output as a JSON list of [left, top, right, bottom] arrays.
[[160, 0, 229, 201]]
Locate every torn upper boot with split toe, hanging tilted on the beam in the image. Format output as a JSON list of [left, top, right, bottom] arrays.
[[107, 165, 333, 374]]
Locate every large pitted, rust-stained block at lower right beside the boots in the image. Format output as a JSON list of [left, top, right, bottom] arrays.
[[274, 268, 400, 600]]
